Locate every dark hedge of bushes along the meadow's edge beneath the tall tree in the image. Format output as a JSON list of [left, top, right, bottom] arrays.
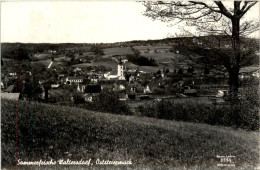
[[138, 97, 259, 130]]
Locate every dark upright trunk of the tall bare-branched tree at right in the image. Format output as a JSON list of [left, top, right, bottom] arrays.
[[228, 16, 241, 103]]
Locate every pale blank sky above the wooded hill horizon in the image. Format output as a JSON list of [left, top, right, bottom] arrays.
[[1, 0, 259, 43]]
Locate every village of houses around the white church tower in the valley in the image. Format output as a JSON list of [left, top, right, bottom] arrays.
[[1, 39, 259, 109]]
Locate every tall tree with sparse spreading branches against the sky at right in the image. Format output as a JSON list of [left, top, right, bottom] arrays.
[[144, 1, 259, 102]]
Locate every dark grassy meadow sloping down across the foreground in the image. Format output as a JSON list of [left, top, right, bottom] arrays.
[[1, 100, 259, 169]]
